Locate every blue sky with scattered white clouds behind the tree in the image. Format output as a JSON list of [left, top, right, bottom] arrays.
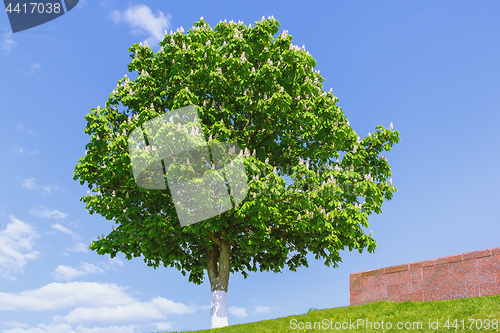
[[0, 0, 500, 333]]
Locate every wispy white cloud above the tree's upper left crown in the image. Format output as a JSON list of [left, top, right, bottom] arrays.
[[110, 5, 171, 46]]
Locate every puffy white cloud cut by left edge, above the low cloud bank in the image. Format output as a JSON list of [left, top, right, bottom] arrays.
[[0, 215, 40, 281]]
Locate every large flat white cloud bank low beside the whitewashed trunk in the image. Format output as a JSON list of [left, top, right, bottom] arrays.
[[0, 282, 196, 333]]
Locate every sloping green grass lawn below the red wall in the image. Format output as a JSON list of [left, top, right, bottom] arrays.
[[152, 295, 500, 333]]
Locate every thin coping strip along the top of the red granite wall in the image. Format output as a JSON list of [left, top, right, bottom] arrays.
[[352, 247, 500, 277]]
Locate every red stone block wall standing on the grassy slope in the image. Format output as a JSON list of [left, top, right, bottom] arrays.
[[349, 247, 500, 305]]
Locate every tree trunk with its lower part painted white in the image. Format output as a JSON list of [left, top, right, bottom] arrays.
[[207, 241, 231, 328]]
